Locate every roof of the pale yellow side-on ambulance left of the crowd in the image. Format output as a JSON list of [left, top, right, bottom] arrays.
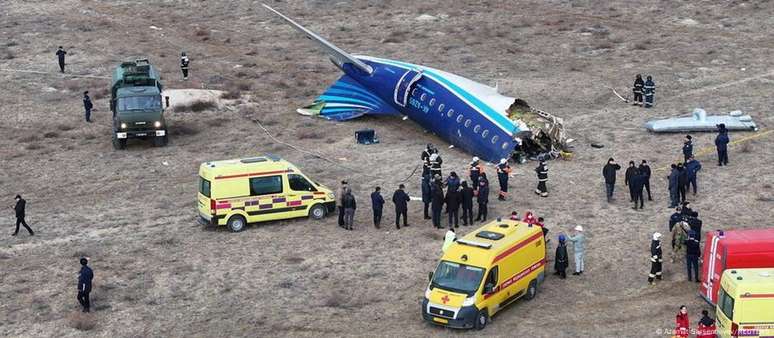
[[199, 154, 299, 180]]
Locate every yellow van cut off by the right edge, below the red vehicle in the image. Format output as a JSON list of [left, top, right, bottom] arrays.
[[715, 268, 774, 337]]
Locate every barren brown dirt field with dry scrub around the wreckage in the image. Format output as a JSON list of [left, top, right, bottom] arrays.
[[0, 0, 774, 337]]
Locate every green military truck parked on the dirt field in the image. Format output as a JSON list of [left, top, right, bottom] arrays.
[[110, 59, 167, 149]]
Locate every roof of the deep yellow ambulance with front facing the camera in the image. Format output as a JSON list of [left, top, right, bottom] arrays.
[[442, 220, 543, 267]]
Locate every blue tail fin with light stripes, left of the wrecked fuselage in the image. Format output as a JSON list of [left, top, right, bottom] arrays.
[[298, 75, 400, 121]]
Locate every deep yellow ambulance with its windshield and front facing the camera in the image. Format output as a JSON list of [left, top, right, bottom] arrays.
[[422, 219, 546, 330]]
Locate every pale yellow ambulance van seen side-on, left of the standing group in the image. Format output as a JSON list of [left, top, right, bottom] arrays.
[[198, 155, 336, 232]]
